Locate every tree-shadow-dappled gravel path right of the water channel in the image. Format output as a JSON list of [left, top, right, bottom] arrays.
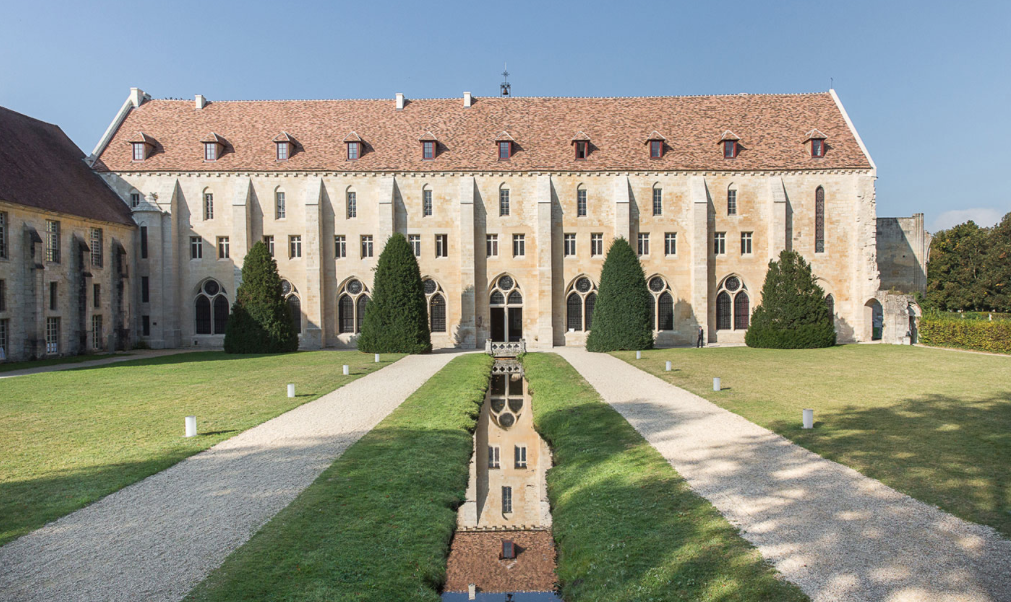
[[556, 348, 1011, 602]]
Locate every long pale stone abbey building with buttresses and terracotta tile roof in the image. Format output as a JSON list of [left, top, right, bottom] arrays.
[[0, 88, 922, 360]]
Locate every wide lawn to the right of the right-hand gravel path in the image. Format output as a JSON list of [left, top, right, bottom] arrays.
[[615, 345, 1011, 535]]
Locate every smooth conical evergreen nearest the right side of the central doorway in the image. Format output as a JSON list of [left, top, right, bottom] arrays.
[[586, 238, 653, 352]]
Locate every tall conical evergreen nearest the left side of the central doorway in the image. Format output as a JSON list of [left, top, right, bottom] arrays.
[[358, 234, 432, 353]]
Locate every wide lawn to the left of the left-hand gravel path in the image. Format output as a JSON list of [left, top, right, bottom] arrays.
[[0, 351, 400, 544]]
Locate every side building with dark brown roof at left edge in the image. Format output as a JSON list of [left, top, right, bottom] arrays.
[[0, 107, 136, 361]]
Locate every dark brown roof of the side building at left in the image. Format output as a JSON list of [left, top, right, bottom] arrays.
[[0, 107, 134, 226]]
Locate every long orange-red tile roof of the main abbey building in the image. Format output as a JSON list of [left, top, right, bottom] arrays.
[[96, 93, 871, 172]]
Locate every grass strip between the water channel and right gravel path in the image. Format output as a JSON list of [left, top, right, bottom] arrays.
[[524, 353, 807, 602]]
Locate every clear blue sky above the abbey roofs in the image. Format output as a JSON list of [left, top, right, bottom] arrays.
[[0, 0, 1011, 229]]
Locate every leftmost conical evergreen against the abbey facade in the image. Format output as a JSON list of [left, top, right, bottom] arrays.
[[224, 242, 298, 353]]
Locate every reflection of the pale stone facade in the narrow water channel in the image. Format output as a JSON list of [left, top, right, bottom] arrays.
[[458, 362, 551, 530]]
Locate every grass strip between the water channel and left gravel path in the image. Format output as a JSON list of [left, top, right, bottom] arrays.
[[186, 354, 492, 602]]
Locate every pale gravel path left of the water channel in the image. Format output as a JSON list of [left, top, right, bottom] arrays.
[[0, 353, 454, 602]]
